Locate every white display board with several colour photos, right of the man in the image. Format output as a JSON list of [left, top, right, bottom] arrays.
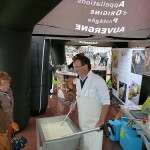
[[112, 48, 145, 105]]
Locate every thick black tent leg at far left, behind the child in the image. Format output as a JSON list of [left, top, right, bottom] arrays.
[[0, 30, 32, 128]]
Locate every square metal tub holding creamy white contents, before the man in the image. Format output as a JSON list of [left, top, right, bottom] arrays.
[[36, 115, 81, 150]]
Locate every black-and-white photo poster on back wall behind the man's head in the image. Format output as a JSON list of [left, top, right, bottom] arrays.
[[65, 45, 111, 71]]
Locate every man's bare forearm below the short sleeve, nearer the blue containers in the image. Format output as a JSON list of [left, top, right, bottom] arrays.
[[96, 105, 110, 127]]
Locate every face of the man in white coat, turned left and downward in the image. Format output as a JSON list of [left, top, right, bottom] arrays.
[[73, 59, 89, 77]]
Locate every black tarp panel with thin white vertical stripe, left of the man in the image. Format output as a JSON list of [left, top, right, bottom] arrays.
[[31, 36, 50, 115]]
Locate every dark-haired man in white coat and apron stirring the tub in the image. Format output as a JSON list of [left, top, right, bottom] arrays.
[[73, 54, 110, 150]]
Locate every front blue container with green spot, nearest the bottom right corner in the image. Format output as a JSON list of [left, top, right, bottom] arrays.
[[120, 124, 142, 150]]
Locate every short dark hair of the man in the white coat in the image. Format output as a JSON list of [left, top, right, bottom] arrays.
[[72, 53, 91, 70]]
